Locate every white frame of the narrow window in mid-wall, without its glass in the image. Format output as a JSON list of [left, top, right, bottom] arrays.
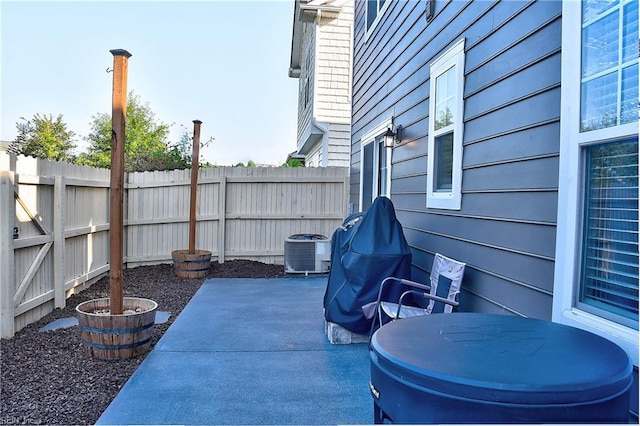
[[427, 38, 465, 210]]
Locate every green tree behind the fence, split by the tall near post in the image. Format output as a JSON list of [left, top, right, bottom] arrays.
[[77, 92, 178, 171]]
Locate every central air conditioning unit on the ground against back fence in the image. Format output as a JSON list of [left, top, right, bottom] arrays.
[[284, 234, 331, 274]]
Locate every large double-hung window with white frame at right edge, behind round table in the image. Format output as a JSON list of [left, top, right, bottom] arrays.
[[553, 0, 639, 366]]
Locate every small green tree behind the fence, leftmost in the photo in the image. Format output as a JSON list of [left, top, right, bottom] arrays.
[[8, 114, 76, 162]]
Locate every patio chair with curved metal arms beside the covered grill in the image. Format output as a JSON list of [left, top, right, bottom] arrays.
[[363, 253, 466, 334]]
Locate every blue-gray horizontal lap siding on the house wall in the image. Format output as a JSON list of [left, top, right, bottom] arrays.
[[350, 0, 561, 319]]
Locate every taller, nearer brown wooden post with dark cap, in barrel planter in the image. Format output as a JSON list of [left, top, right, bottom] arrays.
[[109, 49, 131, 315]]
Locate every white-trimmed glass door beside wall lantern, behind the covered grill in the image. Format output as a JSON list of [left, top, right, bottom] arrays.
[[360, 118, 393, 212]]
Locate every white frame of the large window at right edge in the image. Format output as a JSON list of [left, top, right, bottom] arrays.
[[552, 1, 638, 366]]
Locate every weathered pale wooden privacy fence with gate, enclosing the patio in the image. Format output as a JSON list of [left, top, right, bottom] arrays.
[[0, 152, 349, 338]]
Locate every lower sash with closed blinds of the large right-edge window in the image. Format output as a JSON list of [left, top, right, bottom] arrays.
[[576, 138, 638, 330]]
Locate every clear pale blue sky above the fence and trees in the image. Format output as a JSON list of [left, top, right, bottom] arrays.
[[0, 0, 298, 165]]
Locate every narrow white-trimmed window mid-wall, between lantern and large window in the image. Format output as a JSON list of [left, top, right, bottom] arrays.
[[427, 39, 464, 210]]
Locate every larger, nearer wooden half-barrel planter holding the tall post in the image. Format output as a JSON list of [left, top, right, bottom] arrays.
[[76, 297, 158, 361]]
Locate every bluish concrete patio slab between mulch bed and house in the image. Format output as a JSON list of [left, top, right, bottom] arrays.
[[98, 276, 373, 425]]
